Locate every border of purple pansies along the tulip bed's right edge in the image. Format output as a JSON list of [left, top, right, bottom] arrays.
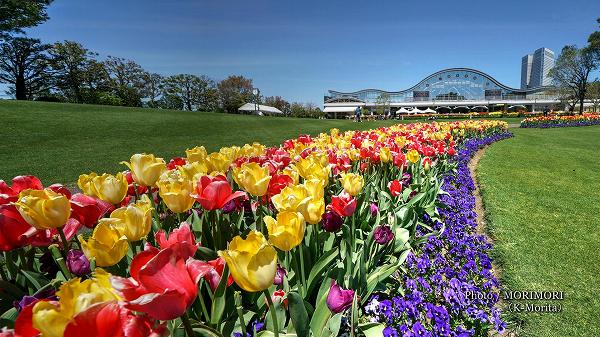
[[365, 132, 512, 337]]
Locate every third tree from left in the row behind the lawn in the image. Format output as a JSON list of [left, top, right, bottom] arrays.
[[103, 56, 145, 107]]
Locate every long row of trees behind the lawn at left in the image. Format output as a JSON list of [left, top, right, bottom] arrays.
[[0, 0, 323, 118]]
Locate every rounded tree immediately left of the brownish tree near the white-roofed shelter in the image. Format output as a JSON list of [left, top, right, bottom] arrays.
[[162, 74, 217, 111]]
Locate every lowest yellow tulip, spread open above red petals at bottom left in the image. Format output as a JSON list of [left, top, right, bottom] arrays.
[[31, 268, 120, 337]]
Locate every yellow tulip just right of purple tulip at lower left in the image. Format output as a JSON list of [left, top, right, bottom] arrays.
[[78, 218, 128, 267]]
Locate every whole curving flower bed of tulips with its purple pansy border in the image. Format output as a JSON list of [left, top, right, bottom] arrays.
[[0, 121, 507, 337]]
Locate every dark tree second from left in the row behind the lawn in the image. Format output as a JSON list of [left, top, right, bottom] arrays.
[[50, 41, 100, 103]]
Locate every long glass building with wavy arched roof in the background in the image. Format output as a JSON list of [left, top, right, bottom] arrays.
[[325, 68, 551, 107]]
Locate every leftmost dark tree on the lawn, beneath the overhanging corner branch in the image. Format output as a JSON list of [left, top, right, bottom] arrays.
[[0, 37, 52, 100]]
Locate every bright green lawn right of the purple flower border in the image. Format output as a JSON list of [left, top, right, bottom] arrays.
[[478, 126, 600, 337]]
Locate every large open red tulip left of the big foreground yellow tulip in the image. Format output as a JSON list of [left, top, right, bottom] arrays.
[[111, 244, 213, 320]]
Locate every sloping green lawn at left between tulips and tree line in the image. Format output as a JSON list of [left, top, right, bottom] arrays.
[[0, 101, 404, 184]]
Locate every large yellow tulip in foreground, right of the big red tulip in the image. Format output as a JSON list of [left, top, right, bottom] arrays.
[[218, 231, 277, 292]]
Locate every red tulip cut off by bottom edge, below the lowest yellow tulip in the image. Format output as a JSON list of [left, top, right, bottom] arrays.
[[64, 302, 168, 337]]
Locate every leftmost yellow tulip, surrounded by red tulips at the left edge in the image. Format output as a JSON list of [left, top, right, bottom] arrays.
[[15, 189, 71, 230]]
